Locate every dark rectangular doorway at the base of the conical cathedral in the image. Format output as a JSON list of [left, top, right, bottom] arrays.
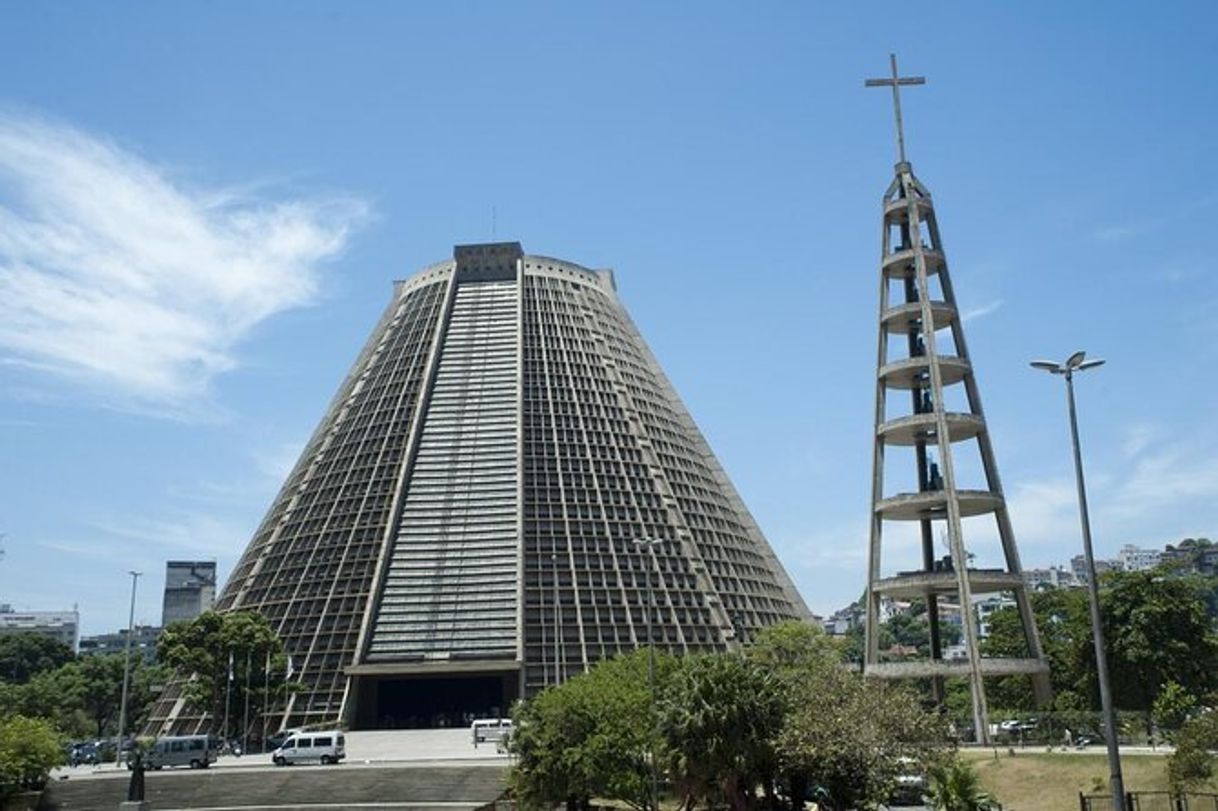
[[356, 673, 519, 729]]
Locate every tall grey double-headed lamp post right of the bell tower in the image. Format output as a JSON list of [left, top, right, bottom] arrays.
[[1032, 352, 1125, 811]]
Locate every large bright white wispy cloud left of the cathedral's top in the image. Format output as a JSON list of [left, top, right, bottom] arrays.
[[0, 111, 369, 414]]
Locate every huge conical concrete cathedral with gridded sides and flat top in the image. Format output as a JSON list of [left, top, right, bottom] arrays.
[[151, 242, 809, 729]]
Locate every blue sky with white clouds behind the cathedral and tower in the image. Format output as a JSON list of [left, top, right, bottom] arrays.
[[0, 2, 1218, 633]]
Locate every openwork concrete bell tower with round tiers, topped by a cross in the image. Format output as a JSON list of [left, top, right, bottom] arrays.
[[864, 55, 1050, 743]]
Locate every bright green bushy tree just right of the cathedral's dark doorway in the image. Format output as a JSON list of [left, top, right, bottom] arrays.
[[508, 650, 676, 809]]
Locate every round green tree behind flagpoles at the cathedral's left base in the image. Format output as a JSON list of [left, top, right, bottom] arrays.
[[157, 611, 286, 734]]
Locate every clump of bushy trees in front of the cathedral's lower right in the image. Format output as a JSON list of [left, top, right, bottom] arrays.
[[510, 622, 948, 811]]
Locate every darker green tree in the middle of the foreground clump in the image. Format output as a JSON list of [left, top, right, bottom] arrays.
[[660, 654, 784, 810]]
